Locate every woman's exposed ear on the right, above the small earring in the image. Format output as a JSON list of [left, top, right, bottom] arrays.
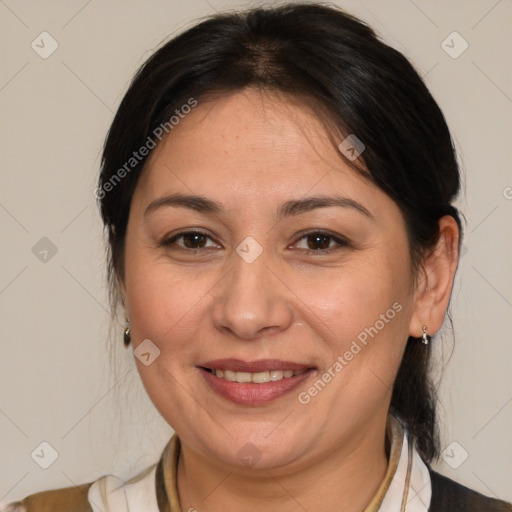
[[409, 215, 460, 338]]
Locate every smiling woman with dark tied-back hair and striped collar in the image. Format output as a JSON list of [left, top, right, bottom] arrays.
[[8, 4, 512, 512]]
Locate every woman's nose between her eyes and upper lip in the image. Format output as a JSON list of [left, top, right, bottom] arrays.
[[213, 251, 293, 340]]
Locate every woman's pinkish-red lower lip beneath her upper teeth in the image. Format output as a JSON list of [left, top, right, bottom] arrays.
[[199, 368, 314, 405]]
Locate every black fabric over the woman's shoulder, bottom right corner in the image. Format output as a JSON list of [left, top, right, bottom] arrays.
[[429, 469, 512, 512]]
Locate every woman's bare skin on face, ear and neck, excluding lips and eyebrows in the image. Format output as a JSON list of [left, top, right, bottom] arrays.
[[120, 90, 458, 512]]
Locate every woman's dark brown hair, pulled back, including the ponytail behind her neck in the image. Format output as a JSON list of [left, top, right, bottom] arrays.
[[95, 3, 460, 462]]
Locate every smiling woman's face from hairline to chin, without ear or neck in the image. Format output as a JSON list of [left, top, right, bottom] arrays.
[[122, 91, 414, 469]]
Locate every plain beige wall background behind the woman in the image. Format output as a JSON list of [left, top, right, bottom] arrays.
[[0, 0, 512, 501]]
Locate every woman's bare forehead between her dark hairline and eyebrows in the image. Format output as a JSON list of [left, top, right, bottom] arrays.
[[138, 90, 379, 212]]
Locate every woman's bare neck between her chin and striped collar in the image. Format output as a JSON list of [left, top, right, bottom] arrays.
[[177, 422, 388, 512]]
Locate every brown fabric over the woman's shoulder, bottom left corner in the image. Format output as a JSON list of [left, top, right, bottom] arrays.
[[0, 482, 92, 512]]
